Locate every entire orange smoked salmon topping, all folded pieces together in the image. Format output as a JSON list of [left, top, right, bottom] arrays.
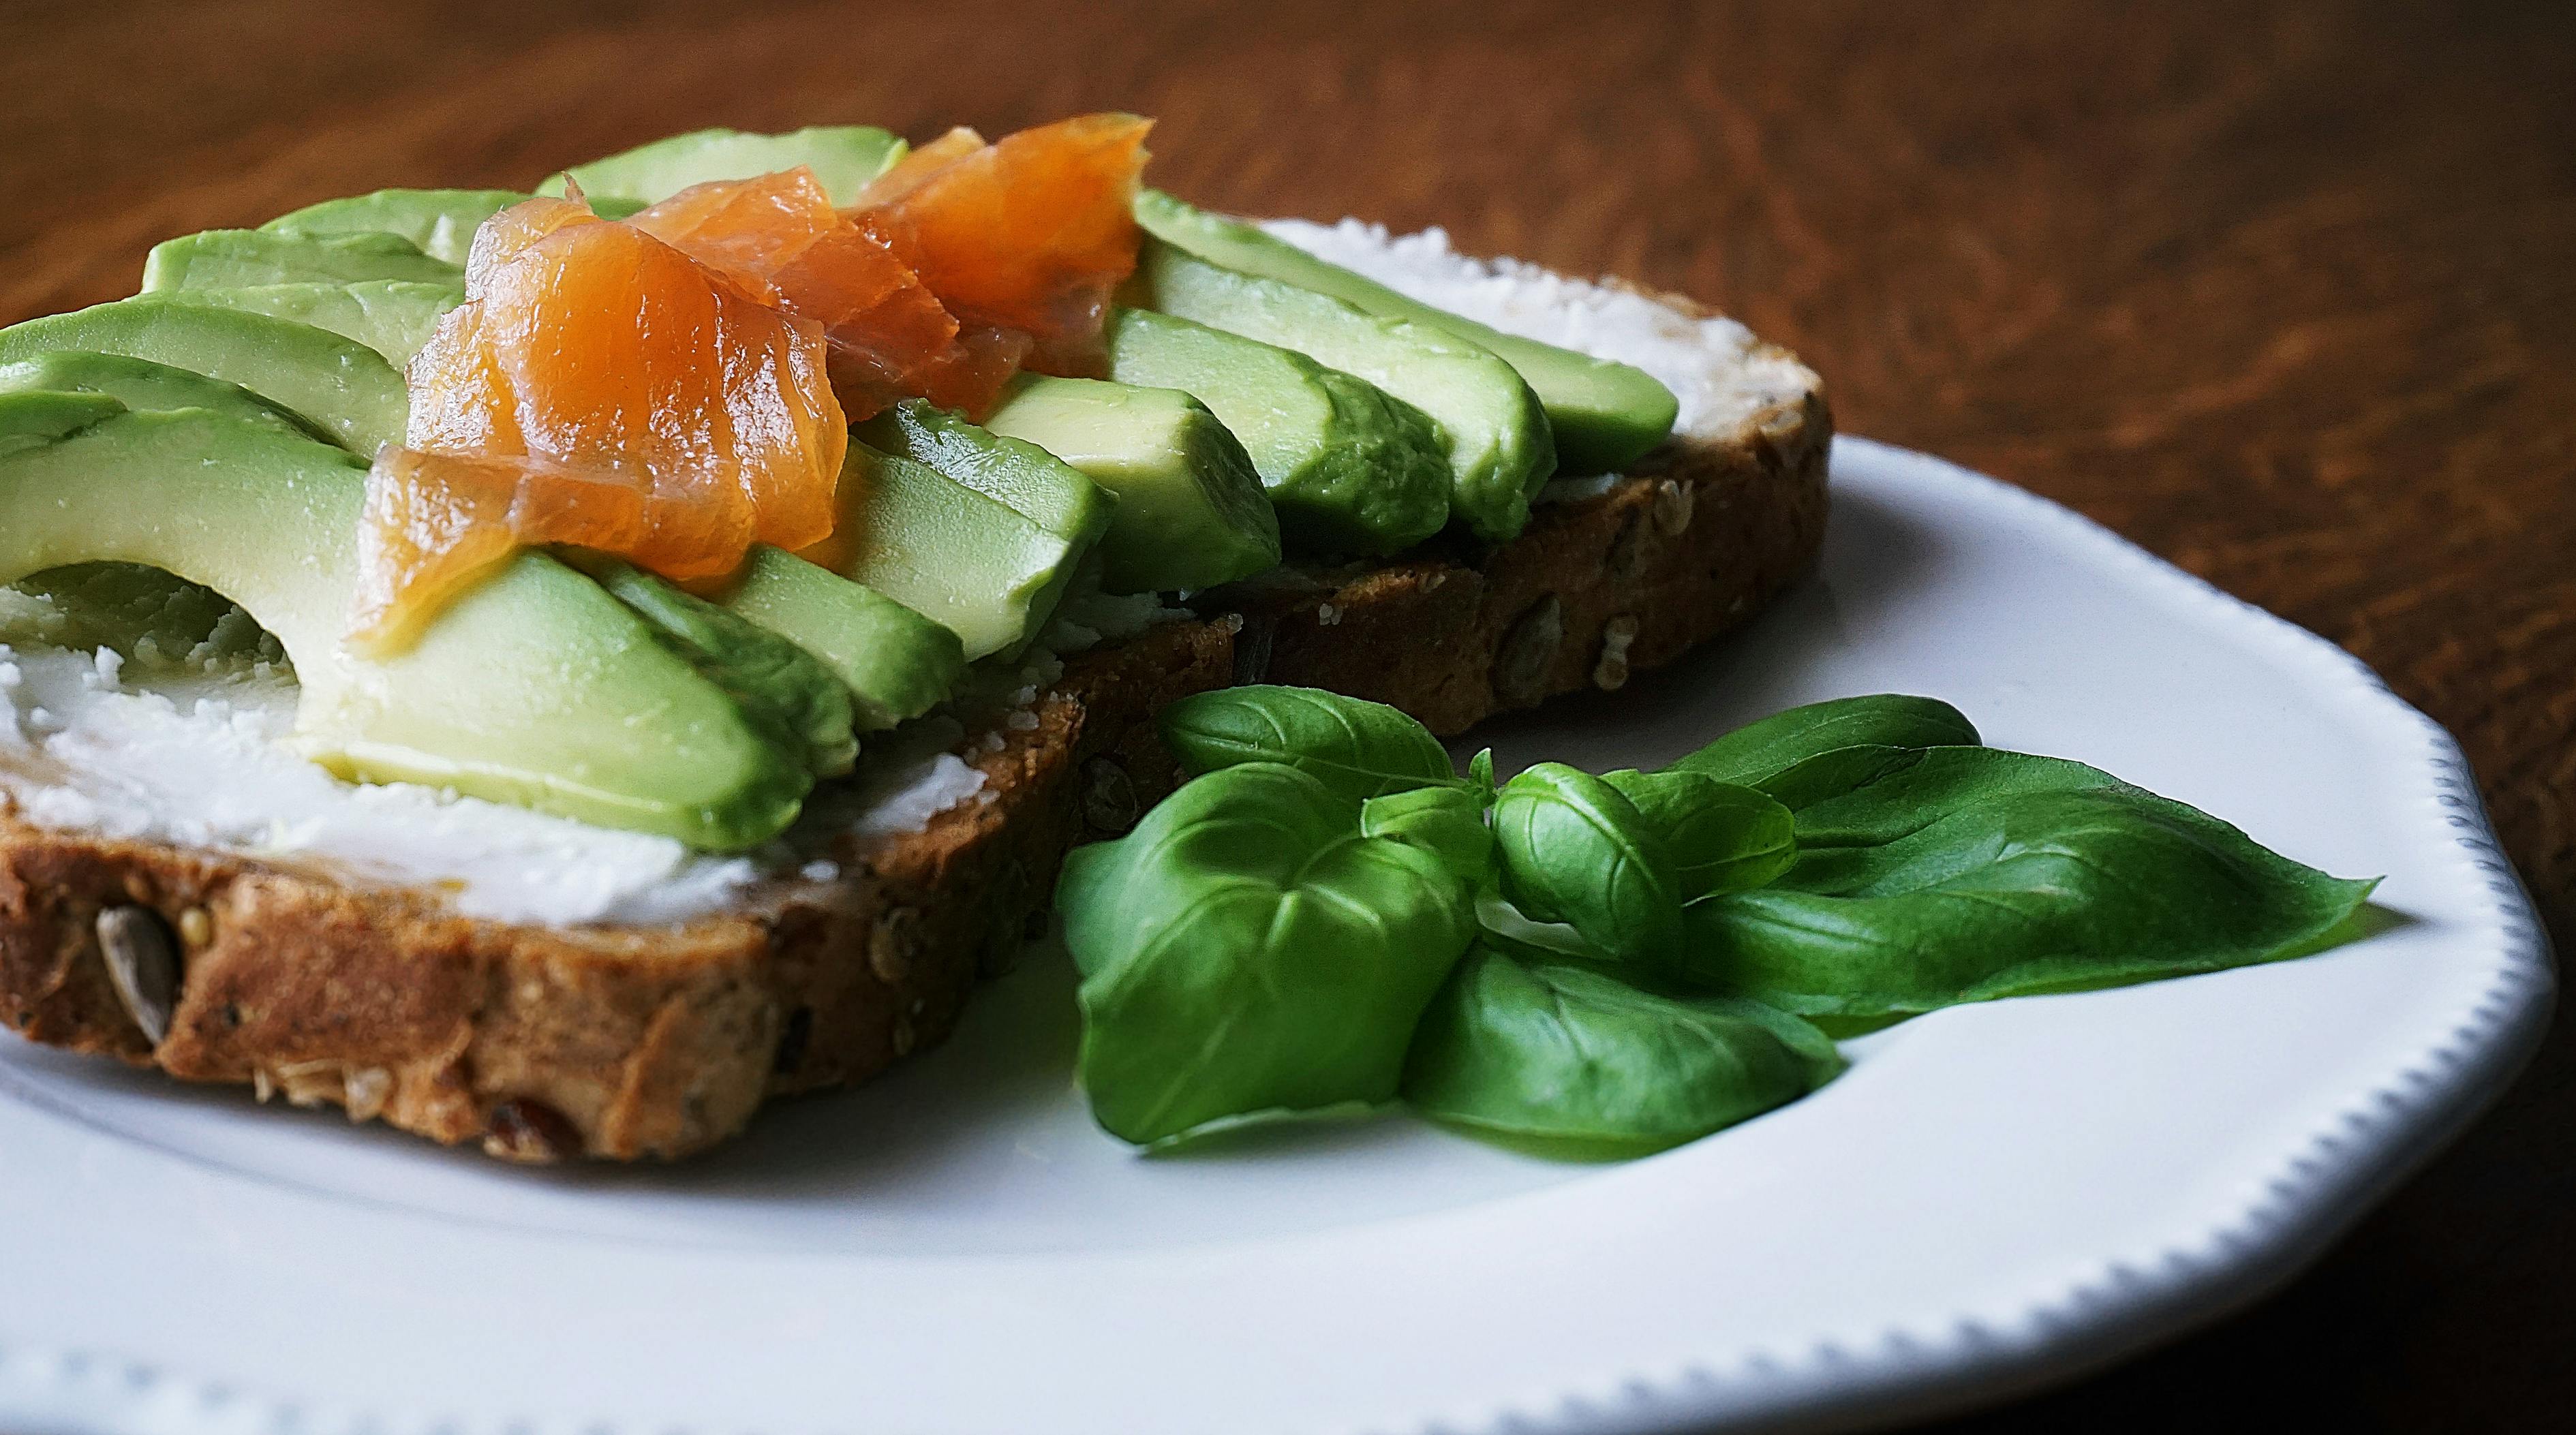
[[350, 113, 1152, 649]]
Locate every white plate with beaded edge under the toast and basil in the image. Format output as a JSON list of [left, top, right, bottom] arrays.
[[0, 441, 2550, 1435]]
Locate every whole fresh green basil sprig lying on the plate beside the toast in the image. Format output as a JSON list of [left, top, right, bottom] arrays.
[[1056, 688, 2372, 1157]]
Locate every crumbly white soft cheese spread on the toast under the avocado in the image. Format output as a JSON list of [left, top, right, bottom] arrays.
[[0, 219, 1816, 925]]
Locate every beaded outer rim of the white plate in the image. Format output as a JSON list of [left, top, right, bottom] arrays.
[[0, 435, 2556, 1435]]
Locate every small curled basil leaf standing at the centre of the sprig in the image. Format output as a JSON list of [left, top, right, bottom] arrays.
[[1494, 762, 1682, 966]]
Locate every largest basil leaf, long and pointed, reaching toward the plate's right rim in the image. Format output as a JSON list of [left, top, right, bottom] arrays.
[[1685, 747, 2375, 1023]]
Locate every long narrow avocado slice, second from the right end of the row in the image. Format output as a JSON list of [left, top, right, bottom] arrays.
[[1136, 237, 1556, 541]]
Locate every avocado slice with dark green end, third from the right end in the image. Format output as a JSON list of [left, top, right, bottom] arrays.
[[1107, 309, 1450, 559]]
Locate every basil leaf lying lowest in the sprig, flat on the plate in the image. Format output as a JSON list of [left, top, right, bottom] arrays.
[[1404, 943, 1842, 1157]]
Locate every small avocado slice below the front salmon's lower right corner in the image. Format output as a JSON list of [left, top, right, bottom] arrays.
[[719, 544, 966, 732]]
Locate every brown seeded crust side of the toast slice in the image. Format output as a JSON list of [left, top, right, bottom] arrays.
[[0, 299, 1832, 1162]]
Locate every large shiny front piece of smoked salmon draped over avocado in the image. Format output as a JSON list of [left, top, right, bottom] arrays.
[[350, 198, 850, 649]]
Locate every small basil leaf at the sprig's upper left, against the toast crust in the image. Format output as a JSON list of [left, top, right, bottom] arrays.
[[1159, 685, 1458, 801]]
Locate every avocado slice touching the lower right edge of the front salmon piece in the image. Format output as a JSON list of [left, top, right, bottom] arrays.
[[799, 438, 1090, 662]]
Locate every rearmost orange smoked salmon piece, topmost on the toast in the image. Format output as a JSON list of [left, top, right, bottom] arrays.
[[853, 113, 1154, 379]]
